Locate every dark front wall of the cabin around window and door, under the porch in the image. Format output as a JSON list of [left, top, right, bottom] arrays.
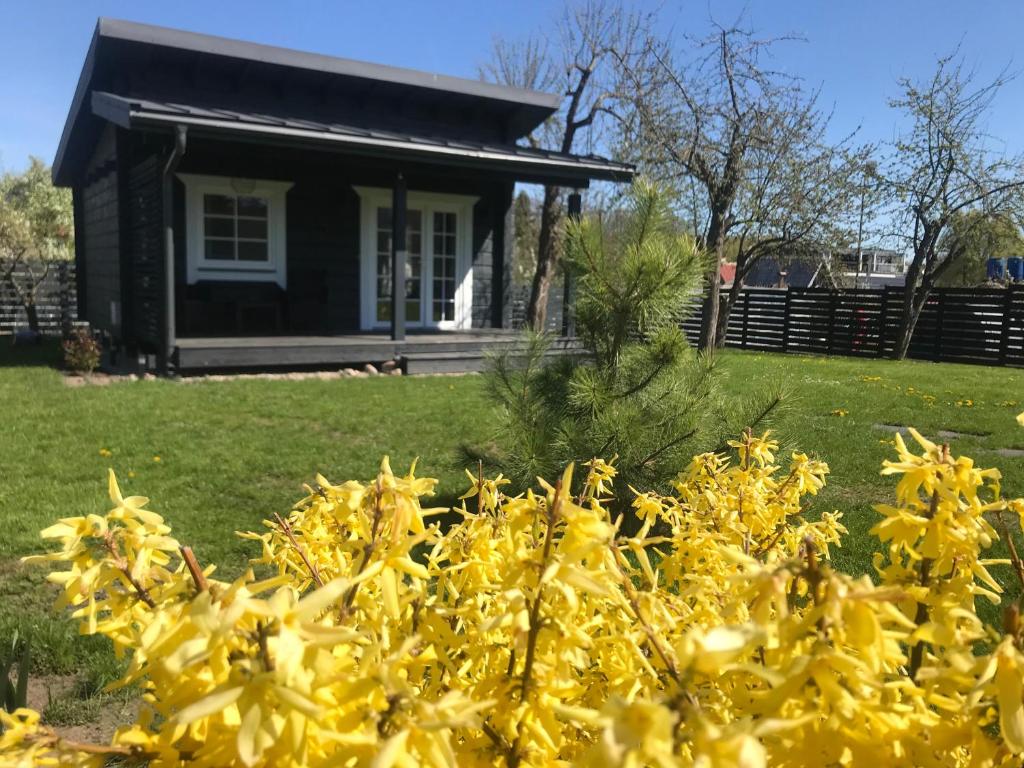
[[174, 139, 513, 337]]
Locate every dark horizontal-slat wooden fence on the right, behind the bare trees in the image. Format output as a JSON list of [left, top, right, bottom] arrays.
[[683, 286, 1024, 367]]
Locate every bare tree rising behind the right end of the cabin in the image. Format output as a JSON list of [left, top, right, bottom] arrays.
[[481, 0, 635, 330]]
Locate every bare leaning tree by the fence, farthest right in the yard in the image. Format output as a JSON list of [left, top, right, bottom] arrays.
[[886, 53, 1024, 359]]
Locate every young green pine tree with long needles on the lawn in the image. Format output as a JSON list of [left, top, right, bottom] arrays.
[[479, 180, 782, 512]]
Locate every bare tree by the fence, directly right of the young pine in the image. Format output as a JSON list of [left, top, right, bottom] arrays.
[[618, 25, 860, 349]]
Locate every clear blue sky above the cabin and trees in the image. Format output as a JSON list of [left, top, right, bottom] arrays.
[[6, 0, 1024, 170]]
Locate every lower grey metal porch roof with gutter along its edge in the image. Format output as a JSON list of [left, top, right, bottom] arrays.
[[92, 92, 634, 181]]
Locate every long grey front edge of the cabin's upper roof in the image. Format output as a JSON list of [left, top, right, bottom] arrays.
[[96, 18, 561, 110]]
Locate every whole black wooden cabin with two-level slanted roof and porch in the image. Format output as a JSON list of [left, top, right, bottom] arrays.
[[53, 18, 633, 371]]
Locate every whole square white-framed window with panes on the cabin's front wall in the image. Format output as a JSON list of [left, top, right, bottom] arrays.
[[178, 173, 292, 288]]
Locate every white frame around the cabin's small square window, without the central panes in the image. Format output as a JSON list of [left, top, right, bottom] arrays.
[[177, 173, 294, 288]]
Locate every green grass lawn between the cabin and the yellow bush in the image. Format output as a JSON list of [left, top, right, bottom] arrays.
[[0, 343, 1024, 721]]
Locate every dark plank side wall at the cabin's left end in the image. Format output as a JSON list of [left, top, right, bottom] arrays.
[[75, 126, 122, 338]]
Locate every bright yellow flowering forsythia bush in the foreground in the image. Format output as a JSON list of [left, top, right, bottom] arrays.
[[6, 433, 1024, 768]]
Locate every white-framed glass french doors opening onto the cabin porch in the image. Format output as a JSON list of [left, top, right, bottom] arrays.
[[357, 189, 473, 330]]
